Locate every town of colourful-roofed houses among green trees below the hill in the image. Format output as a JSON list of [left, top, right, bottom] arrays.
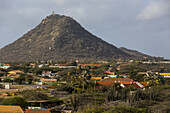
[[0, 59, 170, 113]]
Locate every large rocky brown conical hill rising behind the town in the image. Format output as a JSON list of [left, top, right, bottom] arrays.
[[0, 14, 131, 62]]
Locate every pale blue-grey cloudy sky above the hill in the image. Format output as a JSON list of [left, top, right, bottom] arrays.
[[0, 0, 170, 59]]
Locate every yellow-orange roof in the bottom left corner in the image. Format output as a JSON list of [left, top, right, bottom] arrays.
[[0, 105, 24, 113]]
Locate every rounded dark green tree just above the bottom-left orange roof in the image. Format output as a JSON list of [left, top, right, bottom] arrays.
[[1, 97, 27, 108]]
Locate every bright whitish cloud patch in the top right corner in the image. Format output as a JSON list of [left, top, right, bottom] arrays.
[[137, 0, 170, 20]]
